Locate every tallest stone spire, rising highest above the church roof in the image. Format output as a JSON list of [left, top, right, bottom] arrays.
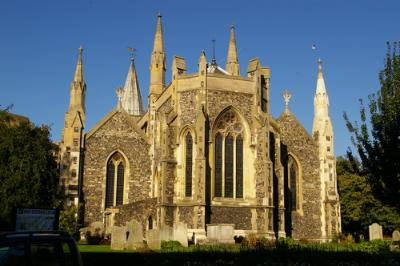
[[149, 14, 166, 97]]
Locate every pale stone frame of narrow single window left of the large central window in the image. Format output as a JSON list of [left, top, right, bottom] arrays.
[[180, 126, 197, 200]]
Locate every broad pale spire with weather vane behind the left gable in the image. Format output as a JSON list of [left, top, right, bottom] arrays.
[[120, 58, 143, 115]]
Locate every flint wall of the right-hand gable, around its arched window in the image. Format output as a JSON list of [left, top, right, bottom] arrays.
[[277, 112, 321, 239]]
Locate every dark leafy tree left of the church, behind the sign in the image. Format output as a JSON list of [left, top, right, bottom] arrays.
[[0, 107, 58, 231]]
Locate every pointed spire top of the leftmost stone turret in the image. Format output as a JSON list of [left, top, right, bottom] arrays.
[[68, 46, 86, 123]]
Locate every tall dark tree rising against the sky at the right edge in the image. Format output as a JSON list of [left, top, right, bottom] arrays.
[[344, 43, 400, 213]]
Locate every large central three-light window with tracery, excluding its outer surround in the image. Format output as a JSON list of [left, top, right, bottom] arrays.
[[214, 109, 243, 198]]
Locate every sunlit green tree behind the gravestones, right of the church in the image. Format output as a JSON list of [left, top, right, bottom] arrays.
[[336, 157, 400, 236]]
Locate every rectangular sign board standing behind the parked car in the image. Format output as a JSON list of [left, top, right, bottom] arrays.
[[15, 208, 58, 231]]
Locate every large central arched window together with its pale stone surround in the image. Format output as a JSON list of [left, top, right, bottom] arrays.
[[209, 106, 255, 204]]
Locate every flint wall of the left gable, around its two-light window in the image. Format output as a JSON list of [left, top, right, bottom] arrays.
[[83, 112, 151, 226]]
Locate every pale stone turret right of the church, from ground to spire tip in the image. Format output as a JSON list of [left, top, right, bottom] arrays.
[[312, 59, 341, 239]]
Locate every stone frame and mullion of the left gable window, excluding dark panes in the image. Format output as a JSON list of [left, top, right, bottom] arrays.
[[102, 150, 130, 209]]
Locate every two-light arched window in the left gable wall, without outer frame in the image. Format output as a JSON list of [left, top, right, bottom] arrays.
[[105, 152, 125, 208]]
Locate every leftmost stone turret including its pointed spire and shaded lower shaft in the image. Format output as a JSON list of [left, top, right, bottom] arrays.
[[60, 47, 86, 205]]
